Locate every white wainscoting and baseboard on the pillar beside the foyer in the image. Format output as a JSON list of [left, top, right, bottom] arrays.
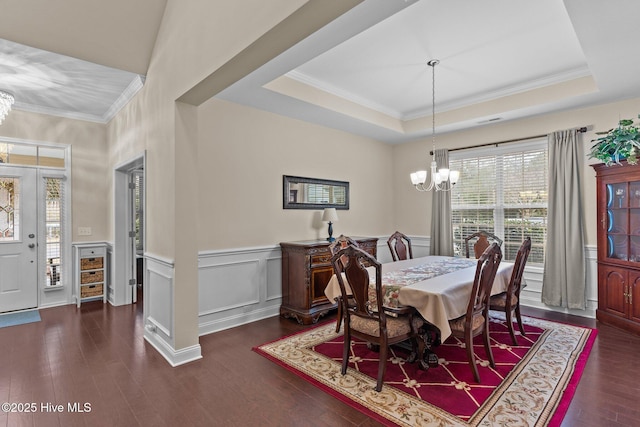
[[143, 253, 202, 366]]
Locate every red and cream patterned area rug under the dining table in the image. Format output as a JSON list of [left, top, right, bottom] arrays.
[[253, 313, 597, 426]]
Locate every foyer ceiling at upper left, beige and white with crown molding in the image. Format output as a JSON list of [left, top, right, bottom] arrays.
[[0, 0, 166, 123]]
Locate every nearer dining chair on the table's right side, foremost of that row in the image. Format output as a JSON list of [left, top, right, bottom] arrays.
[[449, 242, 502, 383]]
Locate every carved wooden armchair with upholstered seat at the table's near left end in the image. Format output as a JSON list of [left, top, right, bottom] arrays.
[[331, 245, 424, 391]]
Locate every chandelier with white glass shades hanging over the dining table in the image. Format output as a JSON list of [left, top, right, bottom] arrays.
[[411, 59, 460, 191]]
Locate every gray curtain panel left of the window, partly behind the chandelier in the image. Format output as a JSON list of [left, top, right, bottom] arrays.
[[430, 150, 453, 256]]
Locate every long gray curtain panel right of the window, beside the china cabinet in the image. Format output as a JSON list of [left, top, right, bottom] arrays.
[[542, 130, 586, 310]]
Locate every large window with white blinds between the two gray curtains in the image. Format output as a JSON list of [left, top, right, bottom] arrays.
[[449, 139, 549, 264]]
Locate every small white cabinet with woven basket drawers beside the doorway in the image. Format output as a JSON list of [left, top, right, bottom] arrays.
[[73, 244, 108, 307]]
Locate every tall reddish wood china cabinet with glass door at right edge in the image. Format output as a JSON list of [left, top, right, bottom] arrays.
[[593, 163, 640, 334]]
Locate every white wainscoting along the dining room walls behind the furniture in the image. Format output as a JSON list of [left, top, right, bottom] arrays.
[[192, 236, 598, 335]]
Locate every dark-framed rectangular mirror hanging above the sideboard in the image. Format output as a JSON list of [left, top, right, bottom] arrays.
[[282, 175, 349, 210]]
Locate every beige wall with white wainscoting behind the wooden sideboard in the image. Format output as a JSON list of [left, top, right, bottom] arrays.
[[197, 99, 396, 334]]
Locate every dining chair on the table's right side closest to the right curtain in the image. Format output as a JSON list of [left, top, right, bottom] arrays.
[[489, 237, 531, 345]]
